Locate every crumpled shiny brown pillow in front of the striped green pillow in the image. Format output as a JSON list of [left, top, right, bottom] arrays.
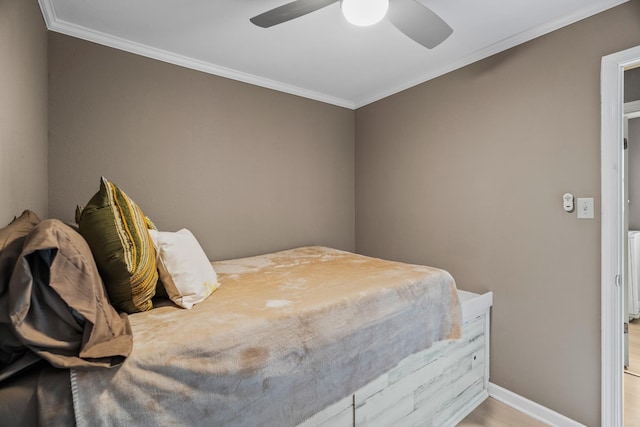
[[7, 219, 133, 368]]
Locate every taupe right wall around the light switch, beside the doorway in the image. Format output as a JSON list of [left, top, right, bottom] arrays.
[[356, 1, 640, 426]]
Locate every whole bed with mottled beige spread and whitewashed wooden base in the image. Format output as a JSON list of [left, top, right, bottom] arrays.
[[0, 209, 491, 426]]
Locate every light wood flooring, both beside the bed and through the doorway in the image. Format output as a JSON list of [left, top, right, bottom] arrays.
[[458, 319, 640, 427]]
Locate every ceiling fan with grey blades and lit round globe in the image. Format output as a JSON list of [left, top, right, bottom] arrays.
[[250, 0, 453, 49]]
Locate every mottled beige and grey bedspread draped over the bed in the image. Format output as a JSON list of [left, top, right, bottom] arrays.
[[71, 247, 460, 427]]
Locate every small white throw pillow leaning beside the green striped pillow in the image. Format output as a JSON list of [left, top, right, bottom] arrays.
[[149, 228, 220, 308]]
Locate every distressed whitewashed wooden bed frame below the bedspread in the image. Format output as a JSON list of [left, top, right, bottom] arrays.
[[299, 291, 493, 427]]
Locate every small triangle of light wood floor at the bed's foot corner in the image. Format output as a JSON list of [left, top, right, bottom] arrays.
[[458, 398, 548, 427]]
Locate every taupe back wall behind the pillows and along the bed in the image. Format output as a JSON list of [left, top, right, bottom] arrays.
[[49, 33, 355, 259]]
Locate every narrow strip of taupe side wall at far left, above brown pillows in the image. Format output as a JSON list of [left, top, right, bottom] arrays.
[[0, 0, 47, 227]]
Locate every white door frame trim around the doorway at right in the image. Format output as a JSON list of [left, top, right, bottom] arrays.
[[600, 46, 640, 427]]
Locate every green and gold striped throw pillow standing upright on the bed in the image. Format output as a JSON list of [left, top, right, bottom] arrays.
[[76, 177, 158, 313]]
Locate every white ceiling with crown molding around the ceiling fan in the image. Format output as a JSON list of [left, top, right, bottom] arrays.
[[39, 0, 628, 108]]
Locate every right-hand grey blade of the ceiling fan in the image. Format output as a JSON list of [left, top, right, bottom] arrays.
[[387, 0, 453, 49]]
